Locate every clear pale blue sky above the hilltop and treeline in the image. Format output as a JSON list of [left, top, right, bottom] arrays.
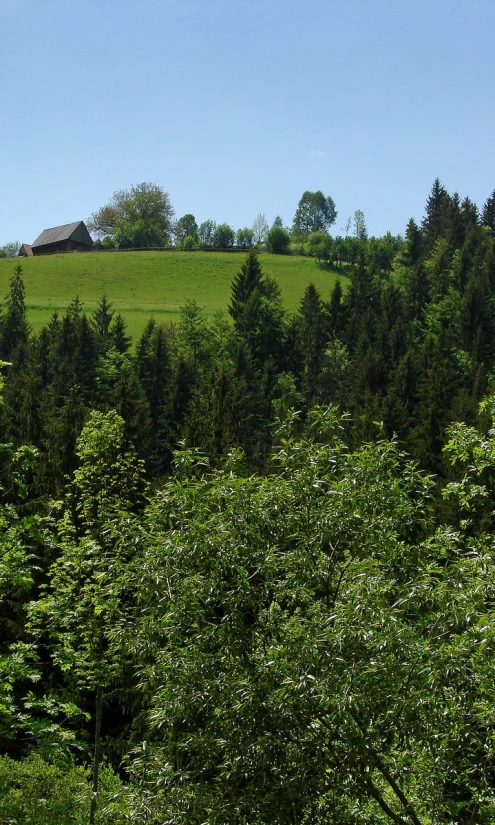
[[0, 0, 495, 245]]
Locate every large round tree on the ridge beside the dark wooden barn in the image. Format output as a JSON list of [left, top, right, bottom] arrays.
[[88, 183, 174, 248]]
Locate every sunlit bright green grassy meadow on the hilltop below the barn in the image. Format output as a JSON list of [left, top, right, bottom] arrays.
[[0, 251, 346, 337]]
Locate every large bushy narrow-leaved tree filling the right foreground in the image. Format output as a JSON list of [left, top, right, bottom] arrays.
[[119, 412, 494, 825]]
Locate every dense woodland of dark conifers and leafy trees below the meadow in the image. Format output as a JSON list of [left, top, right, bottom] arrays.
[[0, 180, 495, 825]]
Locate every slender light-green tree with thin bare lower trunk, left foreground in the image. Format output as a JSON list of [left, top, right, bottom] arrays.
[[31, 412, 144, 825]]
